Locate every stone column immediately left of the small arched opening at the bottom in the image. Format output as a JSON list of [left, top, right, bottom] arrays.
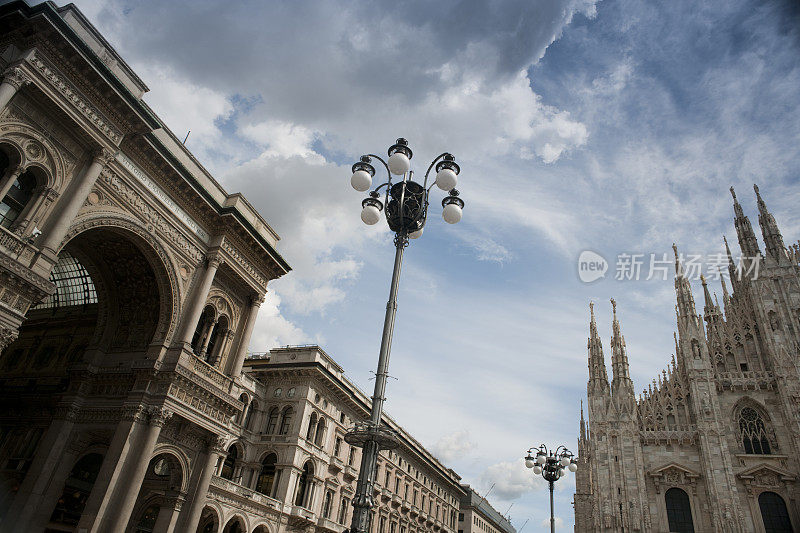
[[101, 407, 172, 531]]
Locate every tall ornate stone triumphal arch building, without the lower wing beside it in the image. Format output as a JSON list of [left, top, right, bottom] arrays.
[[0, 2, 289, 532]]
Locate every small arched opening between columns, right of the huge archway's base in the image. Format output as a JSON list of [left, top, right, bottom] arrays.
[[128, 453, 184, 533]]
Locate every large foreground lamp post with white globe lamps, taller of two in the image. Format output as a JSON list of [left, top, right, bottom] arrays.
[[345, 139, 464, 533]]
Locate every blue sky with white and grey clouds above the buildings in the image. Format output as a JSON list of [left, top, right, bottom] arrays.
[[40, 0, 800, 533]]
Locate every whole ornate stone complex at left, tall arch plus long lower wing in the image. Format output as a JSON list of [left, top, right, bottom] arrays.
[[0, 1, 463, 533]]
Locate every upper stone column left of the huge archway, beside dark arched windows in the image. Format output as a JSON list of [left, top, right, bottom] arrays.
[[39, 148, 114, 256]]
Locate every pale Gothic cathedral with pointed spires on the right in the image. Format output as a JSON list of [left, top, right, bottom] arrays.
[[574, 187, 800, 533]]
